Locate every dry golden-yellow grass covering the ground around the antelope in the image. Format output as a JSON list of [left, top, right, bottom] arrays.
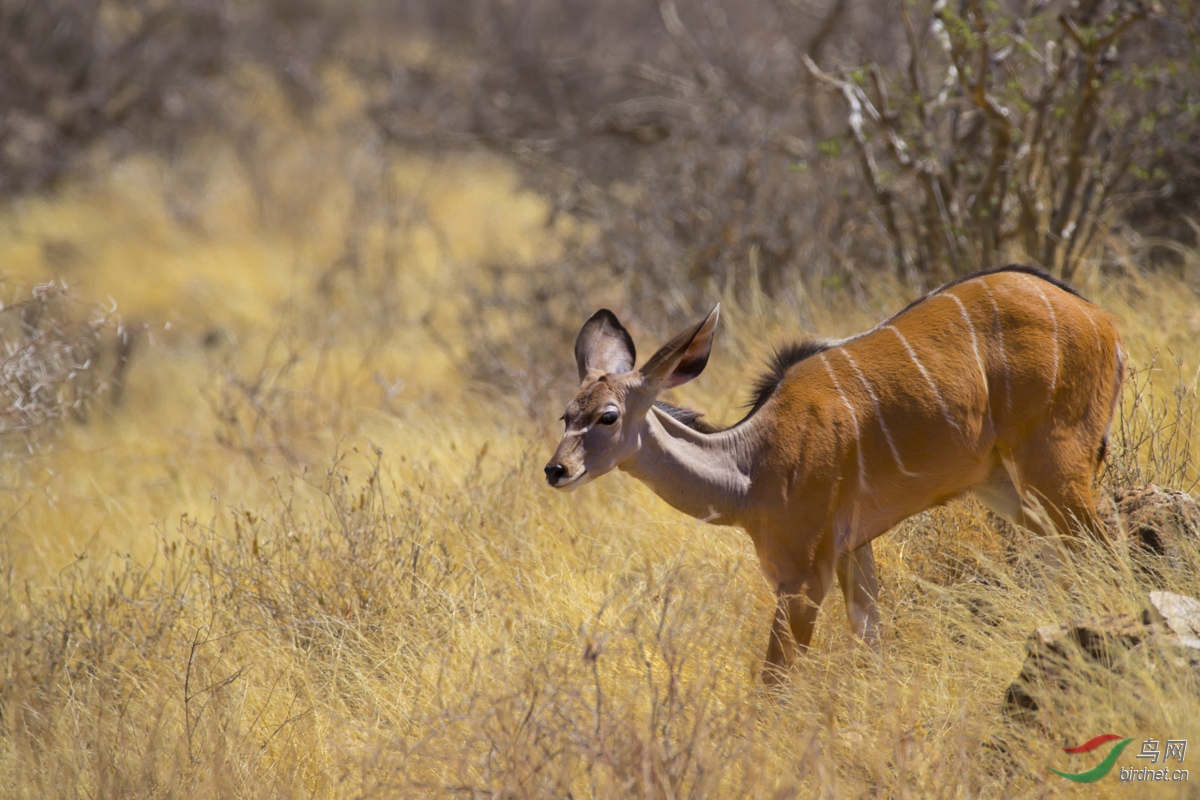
[[0, 92, 1200, 798]]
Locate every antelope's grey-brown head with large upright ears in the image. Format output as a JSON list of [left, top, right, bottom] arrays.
[[545, 305, 721, 489]]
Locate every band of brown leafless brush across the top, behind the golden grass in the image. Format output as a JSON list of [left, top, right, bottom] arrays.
[[7, 0, 1200, 407]]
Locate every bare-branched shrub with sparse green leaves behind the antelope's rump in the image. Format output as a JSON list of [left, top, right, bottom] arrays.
[[808, 0, 1200, 279]]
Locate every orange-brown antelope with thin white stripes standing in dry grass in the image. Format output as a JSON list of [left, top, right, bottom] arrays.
[[545, 265, 1124, 682]]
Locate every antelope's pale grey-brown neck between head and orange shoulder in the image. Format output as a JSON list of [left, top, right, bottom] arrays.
[[620, 408, 755, 525]]
